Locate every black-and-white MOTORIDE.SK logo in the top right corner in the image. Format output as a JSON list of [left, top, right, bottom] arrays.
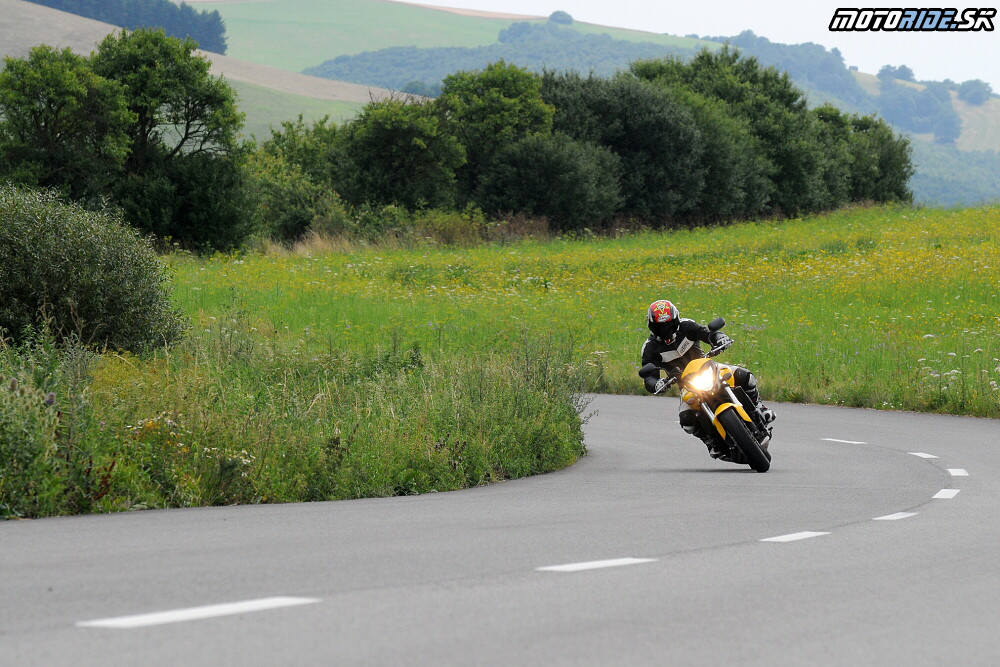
[[830, 7, 997, 32]]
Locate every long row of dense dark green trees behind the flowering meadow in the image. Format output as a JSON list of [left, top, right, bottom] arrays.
[[278, 48, 913, 236]]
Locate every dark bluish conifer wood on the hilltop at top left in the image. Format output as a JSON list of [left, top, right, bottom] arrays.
[[28, 0, 226, 54]]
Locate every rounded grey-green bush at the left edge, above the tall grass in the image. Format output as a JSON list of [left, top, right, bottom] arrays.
[[0, 185, 184, 352]]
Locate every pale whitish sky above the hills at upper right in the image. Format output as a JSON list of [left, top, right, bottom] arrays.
[[417, 0, 1000, 93]]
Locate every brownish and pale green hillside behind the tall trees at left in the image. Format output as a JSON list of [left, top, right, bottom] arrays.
[[0, 0, 389, 136]]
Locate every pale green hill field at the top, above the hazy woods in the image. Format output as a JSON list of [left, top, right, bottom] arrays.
[[198, 0, 718, 72]]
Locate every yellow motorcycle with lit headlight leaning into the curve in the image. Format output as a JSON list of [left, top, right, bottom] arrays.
[[643, 317, 771, 472]]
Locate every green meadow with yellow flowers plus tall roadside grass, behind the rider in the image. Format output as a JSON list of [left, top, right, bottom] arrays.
[[0, 207, 1000, 516]]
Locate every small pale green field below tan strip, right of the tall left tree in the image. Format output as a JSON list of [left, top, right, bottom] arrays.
[[229, 81, 364, 141]]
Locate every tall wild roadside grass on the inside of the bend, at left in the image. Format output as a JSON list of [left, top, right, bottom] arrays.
[[0, 309, 585, 516]]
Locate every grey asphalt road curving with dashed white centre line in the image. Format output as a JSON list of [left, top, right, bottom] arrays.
[[0, 396, 1000, 666]]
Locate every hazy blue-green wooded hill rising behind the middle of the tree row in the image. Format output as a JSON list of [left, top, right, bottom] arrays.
[[305, 19, 695, 97]]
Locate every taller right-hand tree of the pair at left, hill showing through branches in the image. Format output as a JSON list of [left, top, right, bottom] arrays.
[[91, 29, 251, 248]]
